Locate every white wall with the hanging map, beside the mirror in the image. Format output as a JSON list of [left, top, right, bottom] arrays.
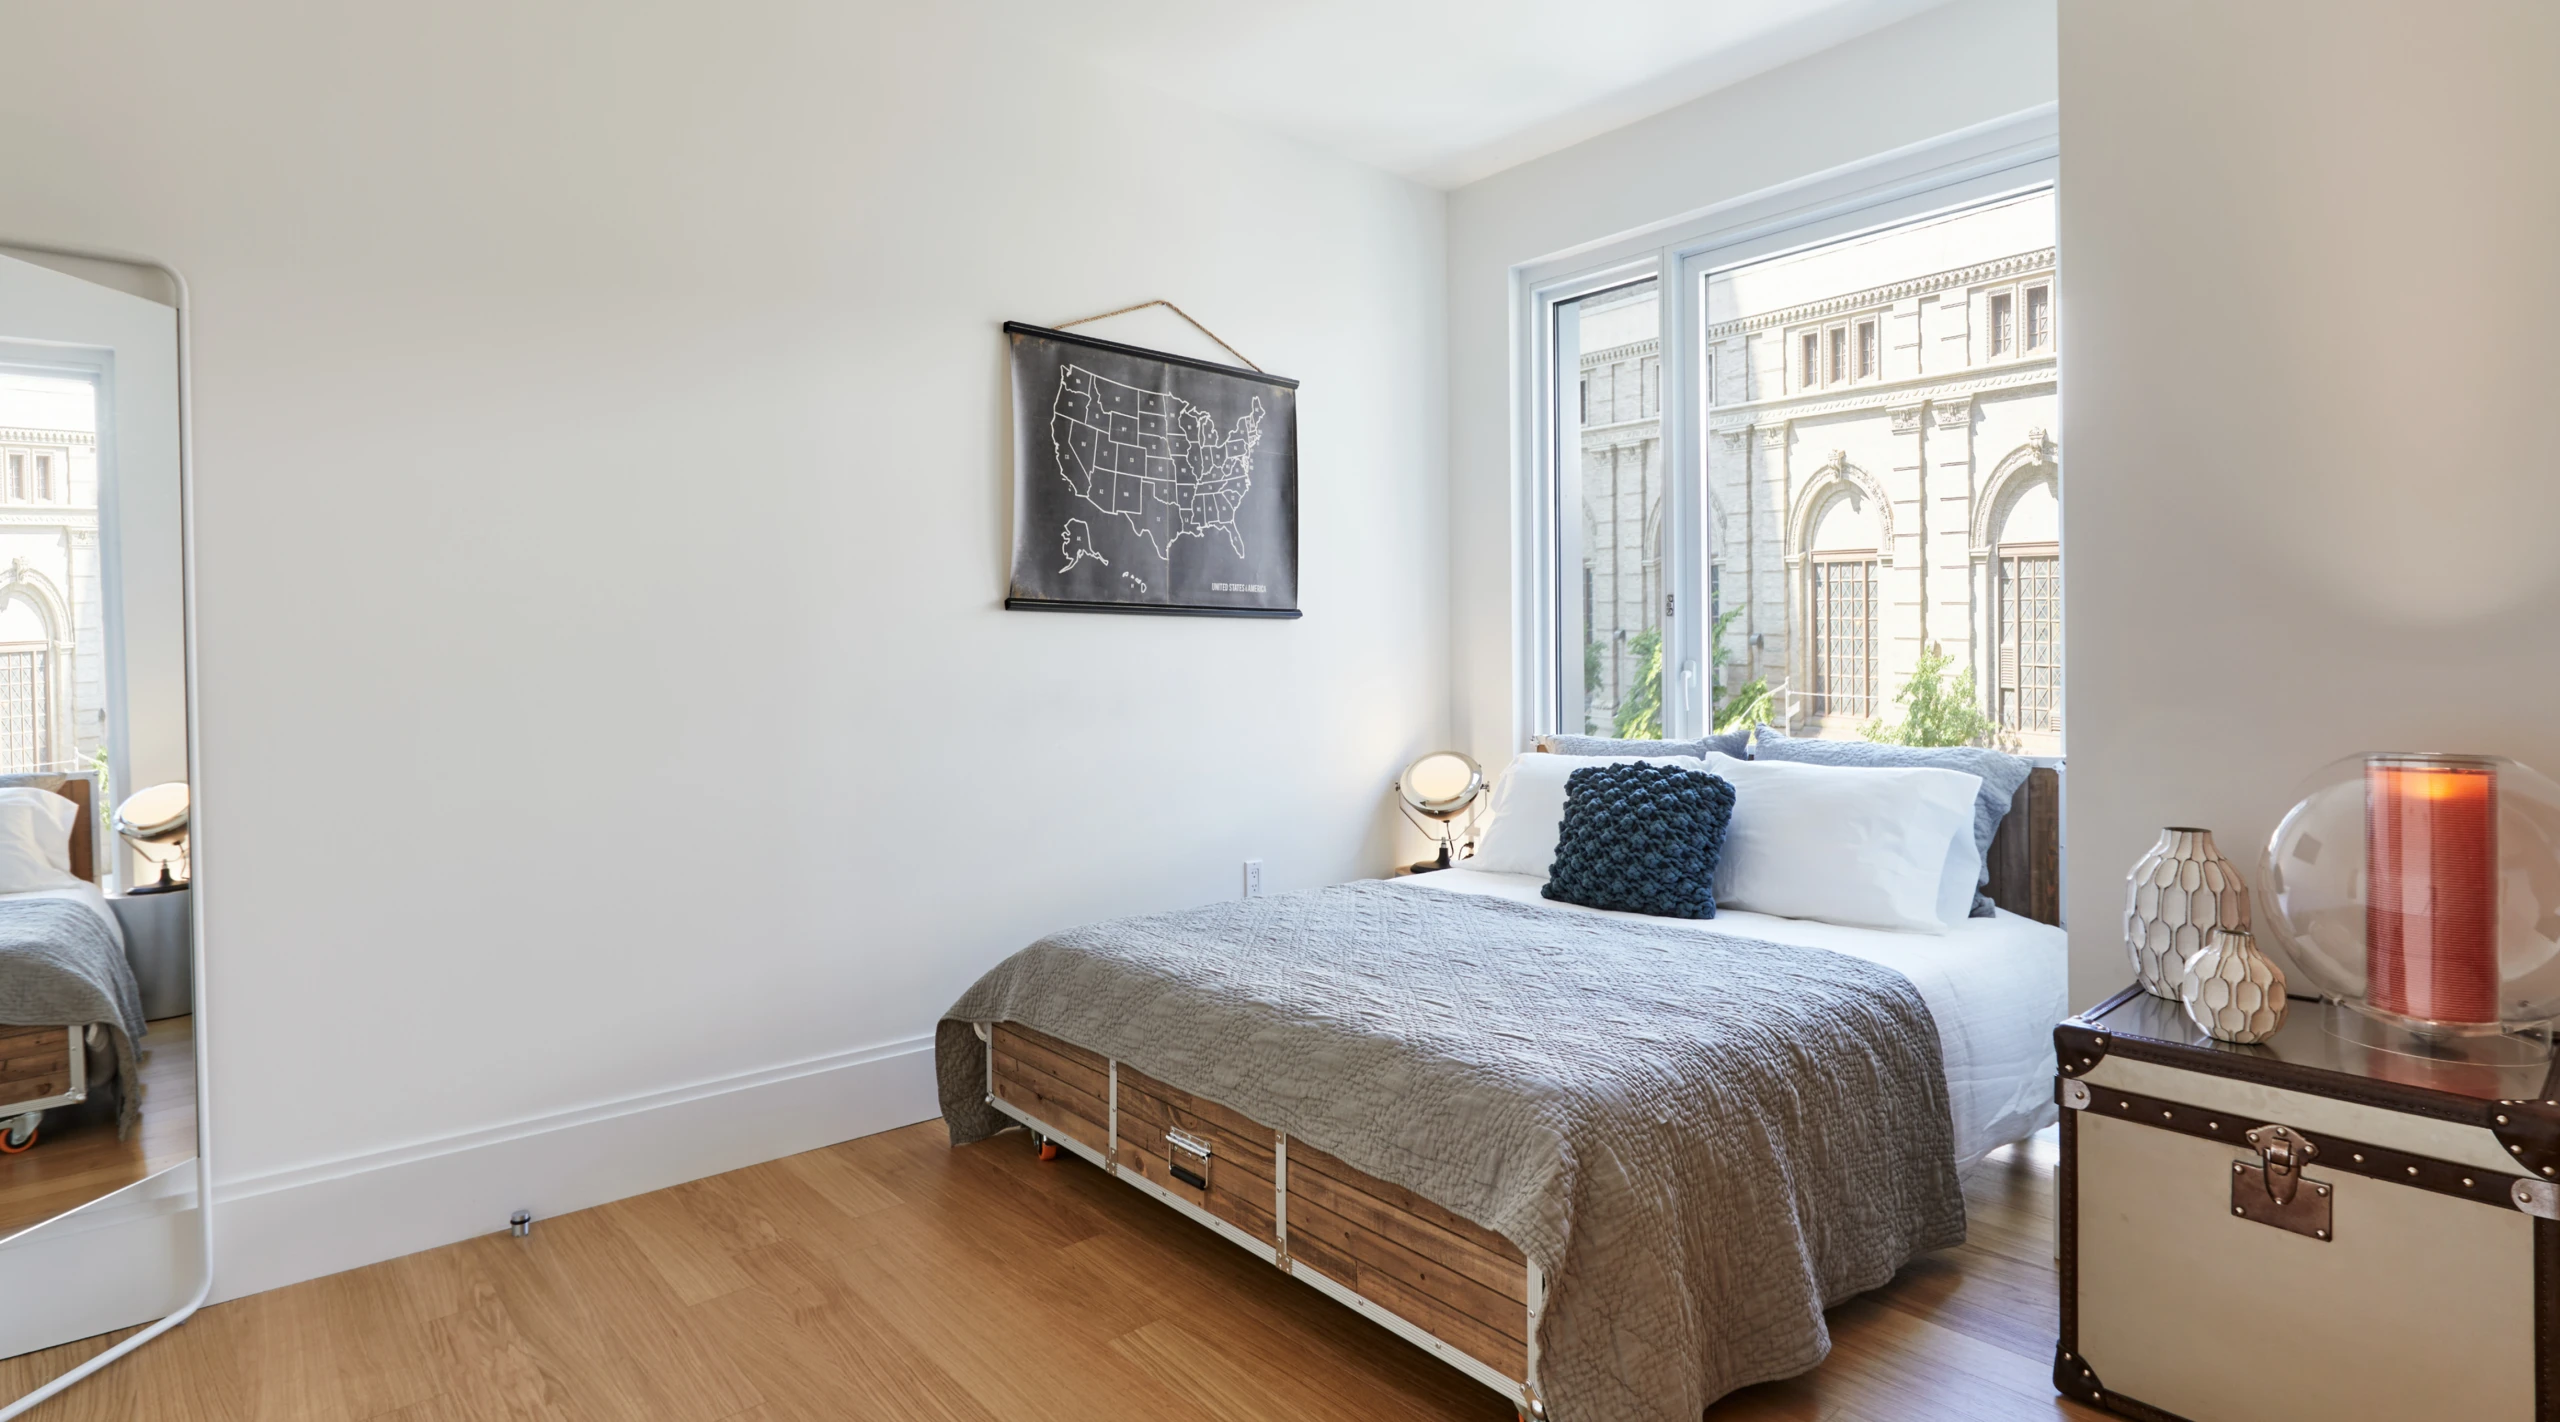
[[0, 0, 1449, 1294]]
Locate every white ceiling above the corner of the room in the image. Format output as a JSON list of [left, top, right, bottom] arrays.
[[993, 0, 1943, 187]]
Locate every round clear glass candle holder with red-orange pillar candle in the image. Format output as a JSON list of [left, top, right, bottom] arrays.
[[2258, 753, 2560, 1066]]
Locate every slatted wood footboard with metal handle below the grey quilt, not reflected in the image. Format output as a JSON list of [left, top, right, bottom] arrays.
[[978, 1022, 1546, 1417]]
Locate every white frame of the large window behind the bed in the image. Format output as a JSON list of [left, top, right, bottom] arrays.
[[1510, 105, 2061, 748]]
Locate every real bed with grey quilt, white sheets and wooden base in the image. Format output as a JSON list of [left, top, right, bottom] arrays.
[[937, 771, 2066, 1422]]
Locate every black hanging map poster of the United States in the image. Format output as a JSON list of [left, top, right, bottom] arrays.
[[1004, 320, 1298, 617]]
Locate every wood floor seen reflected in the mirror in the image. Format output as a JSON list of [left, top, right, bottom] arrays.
[[0, 1017, 195, 1240]]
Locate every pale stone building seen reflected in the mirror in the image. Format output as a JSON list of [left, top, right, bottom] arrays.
[[0, 382, 108, 774]]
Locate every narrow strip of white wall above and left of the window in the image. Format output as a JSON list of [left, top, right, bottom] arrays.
[[1449, 0, 2053, 766]]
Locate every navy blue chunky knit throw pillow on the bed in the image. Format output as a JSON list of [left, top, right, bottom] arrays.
[[1539, 761, 1733, 917]]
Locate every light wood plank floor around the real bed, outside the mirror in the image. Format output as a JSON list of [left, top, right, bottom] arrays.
[[0, 1122, 2097, 1422]]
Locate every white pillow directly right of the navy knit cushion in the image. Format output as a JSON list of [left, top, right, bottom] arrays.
[[1705, 753, 1981, 933]]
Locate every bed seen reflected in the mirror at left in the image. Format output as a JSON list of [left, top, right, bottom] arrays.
[[0, 774, 143, 1153]]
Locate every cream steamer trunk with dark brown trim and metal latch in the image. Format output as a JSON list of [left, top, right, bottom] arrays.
[[2053, 989, 2560, 1422]]
